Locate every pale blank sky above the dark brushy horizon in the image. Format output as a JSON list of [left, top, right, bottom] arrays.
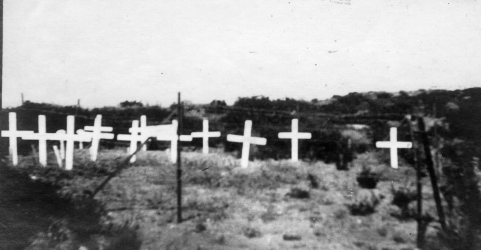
[[3, 0, 481, 107]]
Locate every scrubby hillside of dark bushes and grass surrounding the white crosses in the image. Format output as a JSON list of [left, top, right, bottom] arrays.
[[0, 88, 481, 250]]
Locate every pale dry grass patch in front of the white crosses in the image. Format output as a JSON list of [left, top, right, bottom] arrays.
[[2, 151, 446, 249]]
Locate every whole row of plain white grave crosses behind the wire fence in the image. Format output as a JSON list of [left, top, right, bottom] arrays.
[[1, 113, 412, 170]]
